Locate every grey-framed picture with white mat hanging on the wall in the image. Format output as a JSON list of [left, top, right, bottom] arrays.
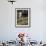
[[15, 8, 31, 28]]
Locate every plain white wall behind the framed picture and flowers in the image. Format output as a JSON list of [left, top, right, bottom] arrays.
[[0, 0, 46, 41]]
